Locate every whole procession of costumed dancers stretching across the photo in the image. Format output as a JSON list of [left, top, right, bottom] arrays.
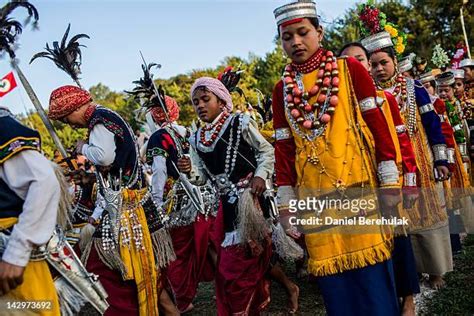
[[0, 1, 474, 316]]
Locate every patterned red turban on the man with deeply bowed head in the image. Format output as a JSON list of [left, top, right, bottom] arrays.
[[48, 86, 92, 120]]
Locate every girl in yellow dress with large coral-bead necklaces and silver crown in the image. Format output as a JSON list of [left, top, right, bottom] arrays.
[[272, 1, 400, 315]]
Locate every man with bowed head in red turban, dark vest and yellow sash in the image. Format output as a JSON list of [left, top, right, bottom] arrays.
[[48, 86, 174, 316]]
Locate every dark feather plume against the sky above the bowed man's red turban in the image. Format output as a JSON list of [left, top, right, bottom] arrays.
[[30, 24, 90, 87]]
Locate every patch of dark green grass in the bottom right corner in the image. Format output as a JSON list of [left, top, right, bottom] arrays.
[[423, 235, 474, 315]]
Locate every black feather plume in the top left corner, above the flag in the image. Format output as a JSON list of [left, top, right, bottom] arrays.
[[0, 0, 39, 58]]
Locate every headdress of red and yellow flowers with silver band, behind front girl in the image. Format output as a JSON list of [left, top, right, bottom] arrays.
[[358, 1, 407, 55]]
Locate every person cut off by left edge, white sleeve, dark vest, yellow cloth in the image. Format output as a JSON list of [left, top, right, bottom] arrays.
[[0, 107, 60, 314]]
